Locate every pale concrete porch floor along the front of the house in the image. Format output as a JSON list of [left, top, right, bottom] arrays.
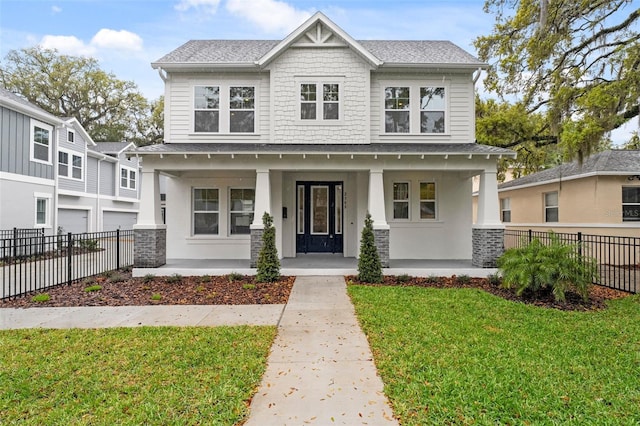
[[133, 253, 497, 277]]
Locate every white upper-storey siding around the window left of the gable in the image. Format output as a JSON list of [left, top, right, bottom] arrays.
[[165, 72, 270, 143]]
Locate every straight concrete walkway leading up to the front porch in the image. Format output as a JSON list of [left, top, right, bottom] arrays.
[[246, 276, 398, 426]]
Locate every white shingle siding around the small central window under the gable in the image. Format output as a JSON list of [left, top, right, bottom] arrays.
[[269, 48, 370, 144]]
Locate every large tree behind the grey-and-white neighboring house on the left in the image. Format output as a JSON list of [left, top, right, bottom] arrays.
[[0, 47, 151, 141]]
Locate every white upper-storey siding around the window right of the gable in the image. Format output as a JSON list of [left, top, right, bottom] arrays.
[[370, 71, 475, 143]]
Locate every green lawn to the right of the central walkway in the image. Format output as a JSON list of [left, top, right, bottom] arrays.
[[349, 286, 640, 426]]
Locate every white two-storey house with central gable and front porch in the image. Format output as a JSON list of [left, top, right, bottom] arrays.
[[132, 13, 515, 267]]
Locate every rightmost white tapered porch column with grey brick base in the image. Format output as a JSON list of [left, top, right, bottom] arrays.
[[471, 170, 504, 268]]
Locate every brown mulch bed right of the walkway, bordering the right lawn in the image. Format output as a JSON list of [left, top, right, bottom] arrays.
[[346, 275, 630, 311]]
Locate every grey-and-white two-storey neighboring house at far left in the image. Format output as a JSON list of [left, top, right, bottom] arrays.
[[0, 89, 139, 235]]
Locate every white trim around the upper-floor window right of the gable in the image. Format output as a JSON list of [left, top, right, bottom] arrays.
[[379, 79, 451, 138]]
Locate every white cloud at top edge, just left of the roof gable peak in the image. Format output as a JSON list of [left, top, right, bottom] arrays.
[[227, 0, 311, 33]]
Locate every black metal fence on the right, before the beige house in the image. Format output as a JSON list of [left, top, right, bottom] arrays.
[[504, 229, 640, 293]]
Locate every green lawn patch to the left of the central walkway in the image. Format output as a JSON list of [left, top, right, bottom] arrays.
[[0, 327, 276, 425]]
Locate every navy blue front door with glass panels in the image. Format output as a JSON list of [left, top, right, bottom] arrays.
[[296, 182, 343, 253]]
